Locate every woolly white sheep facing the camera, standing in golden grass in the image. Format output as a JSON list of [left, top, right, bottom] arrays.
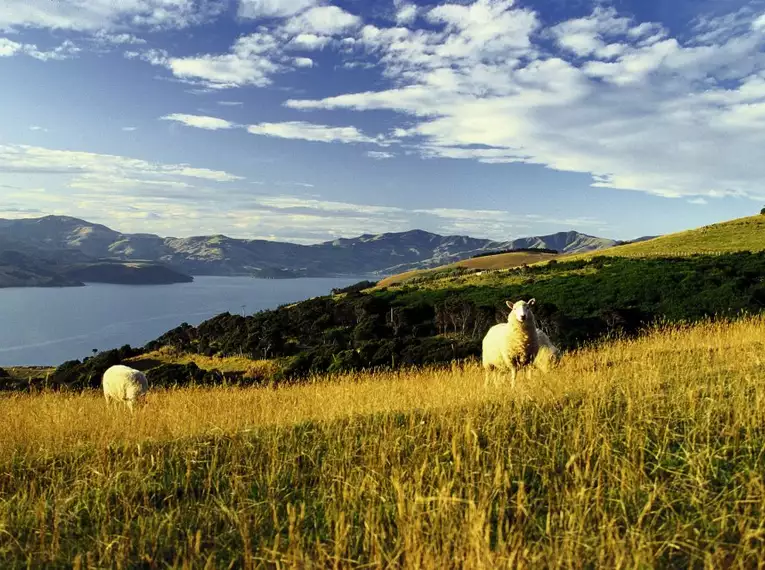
[[482, 299, 549, 386]]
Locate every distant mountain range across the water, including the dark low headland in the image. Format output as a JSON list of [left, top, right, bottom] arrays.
[[0, 216, 632, 286]]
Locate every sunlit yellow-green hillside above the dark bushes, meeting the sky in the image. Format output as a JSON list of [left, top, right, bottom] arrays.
[[562, 215, 765, 261]]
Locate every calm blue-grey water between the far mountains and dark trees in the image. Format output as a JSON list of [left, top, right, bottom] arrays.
[[0, 277, 363, 366]]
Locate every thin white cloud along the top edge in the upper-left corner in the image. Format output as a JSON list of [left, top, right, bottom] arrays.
[[0, 0, 225, 32]]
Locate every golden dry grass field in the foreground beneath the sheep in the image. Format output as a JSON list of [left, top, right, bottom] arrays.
[[0, 312, 765, 569]]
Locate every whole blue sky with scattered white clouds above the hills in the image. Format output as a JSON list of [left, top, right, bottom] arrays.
[[0, 0, 765, 243]]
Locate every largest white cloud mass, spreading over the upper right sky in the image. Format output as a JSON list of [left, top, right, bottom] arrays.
[[285, 0, 765, 198]]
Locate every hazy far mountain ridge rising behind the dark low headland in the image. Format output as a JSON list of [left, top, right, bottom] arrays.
[[0, 216, 617, 278]]
